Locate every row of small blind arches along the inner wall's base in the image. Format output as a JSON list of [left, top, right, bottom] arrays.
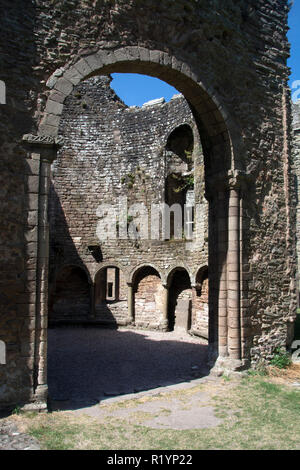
[[49, 266, 208, 339]]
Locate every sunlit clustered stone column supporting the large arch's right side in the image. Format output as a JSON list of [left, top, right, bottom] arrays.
[[208, 170, 249, 371]]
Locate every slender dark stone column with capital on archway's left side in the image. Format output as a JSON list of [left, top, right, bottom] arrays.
[[23, 134, 61, 407]]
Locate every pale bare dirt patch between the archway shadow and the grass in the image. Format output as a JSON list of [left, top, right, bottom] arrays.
[[74, 377, 221, 430]]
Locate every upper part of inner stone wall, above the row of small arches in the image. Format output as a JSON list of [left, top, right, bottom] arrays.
[[49, 76, 208, 325]]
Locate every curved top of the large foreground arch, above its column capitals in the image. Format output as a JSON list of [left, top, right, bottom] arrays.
[[38, 46, 242, 173]]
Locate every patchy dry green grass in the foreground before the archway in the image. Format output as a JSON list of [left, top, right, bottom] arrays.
[[11, 376, 300, 450]]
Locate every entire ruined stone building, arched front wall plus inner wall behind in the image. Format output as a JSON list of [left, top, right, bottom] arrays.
[[0, 0, 297, 406]]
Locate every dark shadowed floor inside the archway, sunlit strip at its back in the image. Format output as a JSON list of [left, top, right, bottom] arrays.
[[48, 327, 209, 410]]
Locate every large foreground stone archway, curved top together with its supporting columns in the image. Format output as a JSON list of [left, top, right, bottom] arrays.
[[24, 47, 248, 404]]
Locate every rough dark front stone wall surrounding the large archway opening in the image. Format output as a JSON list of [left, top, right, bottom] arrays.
[[0, 0, 297, 406]]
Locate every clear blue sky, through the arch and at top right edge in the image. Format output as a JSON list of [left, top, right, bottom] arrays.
[[111, 0, 300, 106]]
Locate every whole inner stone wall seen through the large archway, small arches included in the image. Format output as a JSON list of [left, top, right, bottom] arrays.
[[49, 76, 208, 338]]
